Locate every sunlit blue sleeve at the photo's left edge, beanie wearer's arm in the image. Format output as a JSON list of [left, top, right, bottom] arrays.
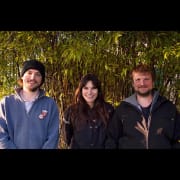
[[0, 99, 16, 149]]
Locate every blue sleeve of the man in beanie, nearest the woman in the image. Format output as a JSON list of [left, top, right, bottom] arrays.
[[42, 100, 60, 149]]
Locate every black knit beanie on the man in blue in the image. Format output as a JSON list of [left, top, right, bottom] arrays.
[[21, 59, 45, 84]]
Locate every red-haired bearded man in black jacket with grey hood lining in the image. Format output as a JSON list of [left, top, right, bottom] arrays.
[[106, 64, 180, 149]]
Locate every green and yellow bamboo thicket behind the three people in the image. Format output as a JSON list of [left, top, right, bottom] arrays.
[[0, 31, 180, 148]]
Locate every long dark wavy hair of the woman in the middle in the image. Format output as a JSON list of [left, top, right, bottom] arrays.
[[72, 73, 109, 126]]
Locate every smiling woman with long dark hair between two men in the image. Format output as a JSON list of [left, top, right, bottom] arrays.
[[62, 74, 114, 149]]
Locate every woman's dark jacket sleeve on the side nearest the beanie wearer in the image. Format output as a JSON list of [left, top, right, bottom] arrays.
[[62, 107, 73, 146]]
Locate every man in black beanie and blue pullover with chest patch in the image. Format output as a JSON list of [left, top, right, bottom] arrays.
[[0, 60, 60, 149]]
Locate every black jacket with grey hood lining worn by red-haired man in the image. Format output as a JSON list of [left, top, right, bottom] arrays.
[[106, 91, 180, 149]]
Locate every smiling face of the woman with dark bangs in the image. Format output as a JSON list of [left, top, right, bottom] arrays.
[[82, 81, 98, 107]]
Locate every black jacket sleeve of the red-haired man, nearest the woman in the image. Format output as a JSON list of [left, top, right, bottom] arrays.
[[105, 107, 122, 149]]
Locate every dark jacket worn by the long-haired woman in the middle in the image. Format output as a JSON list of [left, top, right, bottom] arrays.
[[62, 103, 114, 149]]
